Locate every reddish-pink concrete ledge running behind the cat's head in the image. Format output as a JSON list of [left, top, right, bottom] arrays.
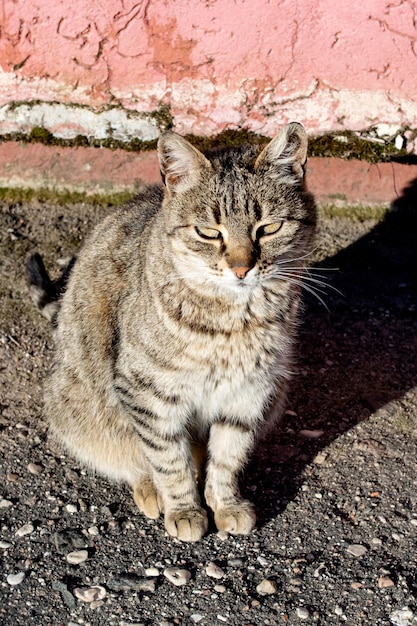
[[0, 142, 417, 206]]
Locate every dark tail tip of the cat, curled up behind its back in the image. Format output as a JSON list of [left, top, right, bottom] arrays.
[[26, 252, 75, 326]]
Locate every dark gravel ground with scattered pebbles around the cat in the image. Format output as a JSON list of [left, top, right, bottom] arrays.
[[0, 197, 417, 626]]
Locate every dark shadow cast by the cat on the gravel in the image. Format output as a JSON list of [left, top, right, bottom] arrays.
[[249, 173, 417, 526]]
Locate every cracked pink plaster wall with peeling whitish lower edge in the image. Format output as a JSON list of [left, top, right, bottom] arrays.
[[0, 0, 417, 139]]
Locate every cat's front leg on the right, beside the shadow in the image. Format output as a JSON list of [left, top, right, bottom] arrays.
[[204, 421, 256, 535]]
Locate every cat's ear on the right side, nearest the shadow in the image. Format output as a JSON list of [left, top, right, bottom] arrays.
[[255, 122, 308, 183]]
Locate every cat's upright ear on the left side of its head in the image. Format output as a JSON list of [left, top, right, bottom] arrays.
[[158, 131, 212, 193]]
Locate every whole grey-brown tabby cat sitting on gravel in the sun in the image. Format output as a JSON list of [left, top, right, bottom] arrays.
[[27, 122, 316, 541]]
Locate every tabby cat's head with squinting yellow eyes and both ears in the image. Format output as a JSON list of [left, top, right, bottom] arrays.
[[158, 122, 316, 293]]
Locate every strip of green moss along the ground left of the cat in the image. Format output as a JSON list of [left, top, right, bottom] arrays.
[[0, 187, 133, 206]]
